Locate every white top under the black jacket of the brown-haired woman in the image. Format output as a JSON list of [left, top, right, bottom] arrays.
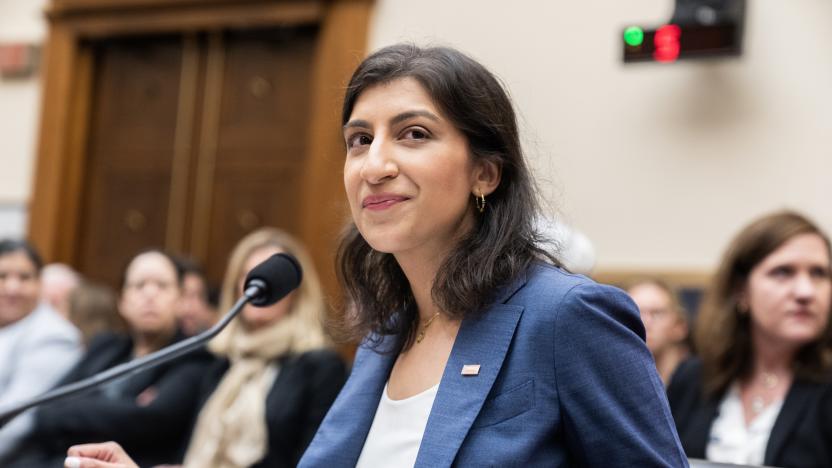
[[705, 385, 783, 465]]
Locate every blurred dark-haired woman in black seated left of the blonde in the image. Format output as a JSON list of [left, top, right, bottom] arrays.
[[7, 250, 212, 468]]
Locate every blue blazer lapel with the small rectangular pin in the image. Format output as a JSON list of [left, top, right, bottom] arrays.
[[415, 277, 525, 467]]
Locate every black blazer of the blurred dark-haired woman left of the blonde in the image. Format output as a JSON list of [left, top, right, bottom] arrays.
[[12, 334, 214, 468]]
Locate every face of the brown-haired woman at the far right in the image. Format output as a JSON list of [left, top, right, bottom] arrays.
[[741, 234, 832, 349]]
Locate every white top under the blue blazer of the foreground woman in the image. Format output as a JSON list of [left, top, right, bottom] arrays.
[[355, 384, 439, 468]]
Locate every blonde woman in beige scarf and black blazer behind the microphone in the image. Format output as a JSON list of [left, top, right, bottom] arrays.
[[67, 228, 347, 468]]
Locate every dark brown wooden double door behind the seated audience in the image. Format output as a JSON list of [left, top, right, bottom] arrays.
[[75, 26, 316, 286]]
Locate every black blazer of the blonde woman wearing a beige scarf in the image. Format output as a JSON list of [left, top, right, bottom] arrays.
[[180, 350, 347, 468]]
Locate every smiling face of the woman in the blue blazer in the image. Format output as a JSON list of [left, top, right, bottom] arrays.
[[344, 78, 488, 257]]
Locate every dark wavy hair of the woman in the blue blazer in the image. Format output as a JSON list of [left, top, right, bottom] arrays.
[[336, 44, 559, 348]]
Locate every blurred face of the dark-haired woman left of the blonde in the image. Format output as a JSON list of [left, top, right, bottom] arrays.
[[119, 252, 181, 334]]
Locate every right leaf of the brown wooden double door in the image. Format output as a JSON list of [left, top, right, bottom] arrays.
[[195, 28, 316, 280]]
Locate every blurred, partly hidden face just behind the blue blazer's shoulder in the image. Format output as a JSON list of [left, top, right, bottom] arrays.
[[628, 283, 688, 356]]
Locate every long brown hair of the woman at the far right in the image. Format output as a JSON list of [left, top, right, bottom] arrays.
[[694, 211, 832, 398]]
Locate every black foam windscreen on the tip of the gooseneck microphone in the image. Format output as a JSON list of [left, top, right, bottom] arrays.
[[245, 253, 303, 307]]
